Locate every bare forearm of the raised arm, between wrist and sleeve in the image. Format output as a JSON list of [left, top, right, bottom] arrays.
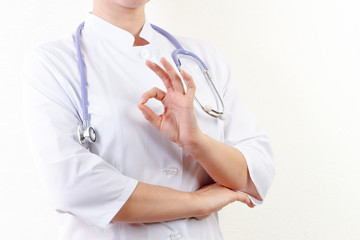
[[184, 134, 261, 200]]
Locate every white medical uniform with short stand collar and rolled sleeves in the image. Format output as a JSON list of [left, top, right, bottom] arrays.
[[24, 13, 274, 240]]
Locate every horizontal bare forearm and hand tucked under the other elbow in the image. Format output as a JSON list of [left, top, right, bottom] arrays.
[[112, 183, 254, 223]]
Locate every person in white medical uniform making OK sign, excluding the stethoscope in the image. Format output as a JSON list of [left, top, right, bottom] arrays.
[[24, 0, 274, 240]]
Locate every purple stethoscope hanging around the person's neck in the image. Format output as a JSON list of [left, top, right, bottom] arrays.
[[75, 22, 225, 144]]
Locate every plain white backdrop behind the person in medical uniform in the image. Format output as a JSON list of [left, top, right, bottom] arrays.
[[0, 0, 360, 240]]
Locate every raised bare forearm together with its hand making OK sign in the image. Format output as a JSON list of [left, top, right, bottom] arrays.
[[138, 58, 260, 199]]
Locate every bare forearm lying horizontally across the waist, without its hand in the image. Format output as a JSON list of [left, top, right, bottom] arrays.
[[111, 182, 202, 223]]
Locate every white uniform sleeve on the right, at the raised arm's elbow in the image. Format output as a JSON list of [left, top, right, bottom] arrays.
[[214, 44, 275, 205]]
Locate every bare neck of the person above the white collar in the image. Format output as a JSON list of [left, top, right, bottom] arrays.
[[92, 0, 148, 46]]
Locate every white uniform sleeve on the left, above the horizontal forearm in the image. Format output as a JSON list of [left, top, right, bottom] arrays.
[[23, 47, 138, 231]]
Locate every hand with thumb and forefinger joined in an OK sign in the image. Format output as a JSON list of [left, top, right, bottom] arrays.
[[138, 57, 201, 148]]
